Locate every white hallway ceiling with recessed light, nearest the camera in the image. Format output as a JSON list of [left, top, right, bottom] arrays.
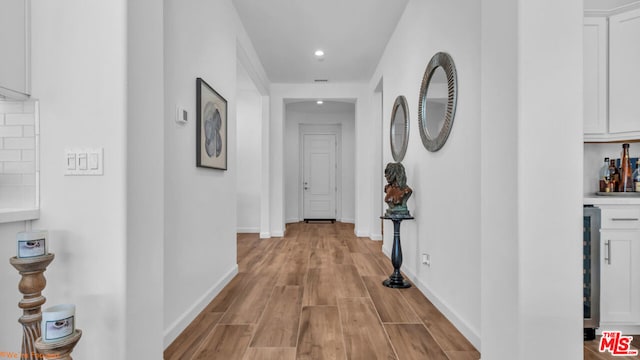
[[233, 0, 408, 83]]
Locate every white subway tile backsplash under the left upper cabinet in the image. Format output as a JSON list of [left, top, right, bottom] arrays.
[[0, 100, 38, 209]]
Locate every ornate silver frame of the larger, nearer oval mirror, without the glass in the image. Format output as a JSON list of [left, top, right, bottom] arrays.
[[418, 52, 458, 152]]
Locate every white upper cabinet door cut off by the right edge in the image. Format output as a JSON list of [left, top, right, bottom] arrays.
[[609, 9, 640, 134]]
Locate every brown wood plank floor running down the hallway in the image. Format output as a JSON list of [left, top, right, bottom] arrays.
[[164, 223, 480, 360]]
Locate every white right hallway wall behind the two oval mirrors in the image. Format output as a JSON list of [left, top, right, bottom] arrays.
[[370, 0, 480, 346]]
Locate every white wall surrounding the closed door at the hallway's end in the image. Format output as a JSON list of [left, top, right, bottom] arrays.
[[284, 101, 356, 223]]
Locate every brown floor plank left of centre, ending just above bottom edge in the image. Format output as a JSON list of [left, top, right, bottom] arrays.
[[251, 286, 302, 347]]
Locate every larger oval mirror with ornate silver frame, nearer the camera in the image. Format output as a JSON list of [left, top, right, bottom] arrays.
[[418, 52, 458, 151]]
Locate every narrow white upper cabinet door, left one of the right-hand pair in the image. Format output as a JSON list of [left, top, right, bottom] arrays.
[[582, 17, 608, 134]]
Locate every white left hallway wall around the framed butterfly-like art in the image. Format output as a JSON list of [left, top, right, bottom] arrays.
[[164, 0, 266, 346]]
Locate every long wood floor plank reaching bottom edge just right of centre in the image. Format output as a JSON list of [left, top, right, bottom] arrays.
[[338, 298, 397, 360]]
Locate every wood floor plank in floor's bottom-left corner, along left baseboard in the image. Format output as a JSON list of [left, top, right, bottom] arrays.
[[164, 312, 224, 360]]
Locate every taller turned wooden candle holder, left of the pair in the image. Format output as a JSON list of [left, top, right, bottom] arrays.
[[9, 254, 55, 360]]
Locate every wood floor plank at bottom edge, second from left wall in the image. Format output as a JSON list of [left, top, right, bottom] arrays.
[[192, 324, 253, 360]]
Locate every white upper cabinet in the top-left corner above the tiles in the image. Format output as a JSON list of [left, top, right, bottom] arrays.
[[0, 0, 31, 99]]
